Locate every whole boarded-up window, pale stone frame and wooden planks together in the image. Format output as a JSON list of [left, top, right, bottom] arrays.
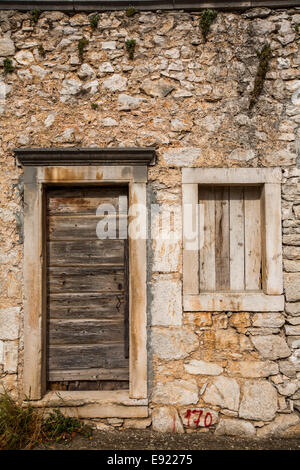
[[182, 168, 283, 311]]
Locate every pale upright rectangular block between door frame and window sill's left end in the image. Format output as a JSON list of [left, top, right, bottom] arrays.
[[151, 277, 182, 326]]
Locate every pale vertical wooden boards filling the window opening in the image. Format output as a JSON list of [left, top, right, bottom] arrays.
[[199, 186, 262, 292]]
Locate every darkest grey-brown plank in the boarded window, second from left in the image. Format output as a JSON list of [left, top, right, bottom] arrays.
[[215, 186, 230, 291]]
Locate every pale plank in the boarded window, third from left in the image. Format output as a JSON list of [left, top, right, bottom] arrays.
[[229, 186, 245, 291]]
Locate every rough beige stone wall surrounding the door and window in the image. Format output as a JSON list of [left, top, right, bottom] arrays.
[[0, 8, 300, 437]]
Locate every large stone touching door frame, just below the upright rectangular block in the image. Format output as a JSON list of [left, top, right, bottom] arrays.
[[152, 328, 199, 361]]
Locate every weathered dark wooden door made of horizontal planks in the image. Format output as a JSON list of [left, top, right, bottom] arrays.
[[46, 187, 129, 390]]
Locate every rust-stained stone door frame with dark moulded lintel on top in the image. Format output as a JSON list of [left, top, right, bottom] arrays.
[[15, 149, 154, 417]]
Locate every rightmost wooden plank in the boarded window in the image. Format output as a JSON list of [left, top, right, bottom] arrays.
[[245, 186, 261, 290]]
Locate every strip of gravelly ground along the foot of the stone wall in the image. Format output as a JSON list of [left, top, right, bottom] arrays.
[[38, 430, 300, 450]]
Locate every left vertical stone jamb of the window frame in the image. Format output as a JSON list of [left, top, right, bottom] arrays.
[[182, 184, 199, 294]]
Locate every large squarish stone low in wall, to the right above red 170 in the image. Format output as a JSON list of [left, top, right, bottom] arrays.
[[239, 380, 277, 421]]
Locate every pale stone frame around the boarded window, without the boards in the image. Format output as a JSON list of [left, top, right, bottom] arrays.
[[182, 168, 284, 312]]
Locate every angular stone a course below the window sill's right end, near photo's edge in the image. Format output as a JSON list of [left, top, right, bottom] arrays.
[[251, 335, 291, 360]]
